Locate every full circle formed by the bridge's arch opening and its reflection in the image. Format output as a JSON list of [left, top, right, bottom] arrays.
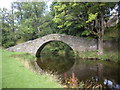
[[36, 40, 75, 74]]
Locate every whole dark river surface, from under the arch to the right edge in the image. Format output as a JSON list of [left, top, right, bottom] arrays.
[[37, 54, 120, 89]]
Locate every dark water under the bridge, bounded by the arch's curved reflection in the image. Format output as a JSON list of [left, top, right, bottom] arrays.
[[37, 54, 75, 74]]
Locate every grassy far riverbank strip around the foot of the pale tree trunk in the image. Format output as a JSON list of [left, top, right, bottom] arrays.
[[77, 51, 120, 63]]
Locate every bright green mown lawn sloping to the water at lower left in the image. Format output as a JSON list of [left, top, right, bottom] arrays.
[[2, 50, 62, 88]]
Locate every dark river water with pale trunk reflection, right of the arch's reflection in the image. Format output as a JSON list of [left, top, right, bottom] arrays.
[[67, 60, 119, 88]]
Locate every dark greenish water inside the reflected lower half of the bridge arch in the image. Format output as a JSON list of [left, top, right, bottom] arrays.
[[37, 54, 74, 73]]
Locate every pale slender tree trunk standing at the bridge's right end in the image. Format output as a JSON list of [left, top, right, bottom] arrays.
[[98, 12, 104, 55]]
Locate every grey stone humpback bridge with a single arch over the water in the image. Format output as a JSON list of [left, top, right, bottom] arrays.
[[7, 34, 97, 57]]
